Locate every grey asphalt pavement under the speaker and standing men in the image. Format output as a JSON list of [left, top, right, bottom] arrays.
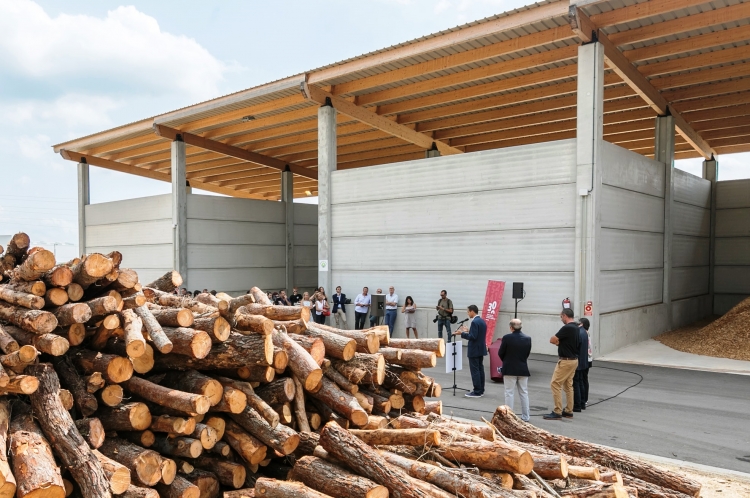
[[430, 345, 750, 473]]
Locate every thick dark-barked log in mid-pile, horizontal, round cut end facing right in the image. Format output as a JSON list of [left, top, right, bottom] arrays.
[[157, 332, 274, 370]]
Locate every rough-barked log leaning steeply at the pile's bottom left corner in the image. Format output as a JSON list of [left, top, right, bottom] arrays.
[[28, 363, 112, 497]]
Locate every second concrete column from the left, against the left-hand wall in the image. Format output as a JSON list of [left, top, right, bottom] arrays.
[[171, 136, 188, 287]]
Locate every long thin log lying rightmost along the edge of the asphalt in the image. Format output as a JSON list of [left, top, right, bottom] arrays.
[[492, 406, 701, 496]]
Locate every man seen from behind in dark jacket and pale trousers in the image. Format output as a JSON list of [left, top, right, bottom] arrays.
[[497, 318, 531, 422]]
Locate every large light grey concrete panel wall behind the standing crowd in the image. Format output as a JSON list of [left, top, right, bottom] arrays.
[[329, 140, 576, 353]]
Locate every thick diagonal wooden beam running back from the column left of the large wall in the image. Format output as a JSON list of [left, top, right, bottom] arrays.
[[302, 83, 463, 155]]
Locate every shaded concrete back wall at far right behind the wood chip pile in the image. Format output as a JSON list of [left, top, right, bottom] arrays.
[[714, 180, 750, 314]]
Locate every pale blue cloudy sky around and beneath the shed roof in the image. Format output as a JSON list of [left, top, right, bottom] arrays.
[[0, 0, 750, 259]]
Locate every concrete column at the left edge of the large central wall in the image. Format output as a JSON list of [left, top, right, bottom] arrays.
[[318, 103, 336, 294]]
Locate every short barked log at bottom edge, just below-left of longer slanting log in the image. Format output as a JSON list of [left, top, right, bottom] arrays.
[[289, 456, 388, 498]]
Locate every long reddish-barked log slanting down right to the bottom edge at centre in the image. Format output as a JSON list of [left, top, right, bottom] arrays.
[[320, 423, 434, 498]]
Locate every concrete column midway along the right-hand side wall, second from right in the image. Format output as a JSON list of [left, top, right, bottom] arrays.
[[654, 116, 675, 330]]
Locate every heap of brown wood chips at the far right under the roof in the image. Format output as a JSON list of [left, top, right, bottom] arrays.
[[654, 298, 750, 361]]
